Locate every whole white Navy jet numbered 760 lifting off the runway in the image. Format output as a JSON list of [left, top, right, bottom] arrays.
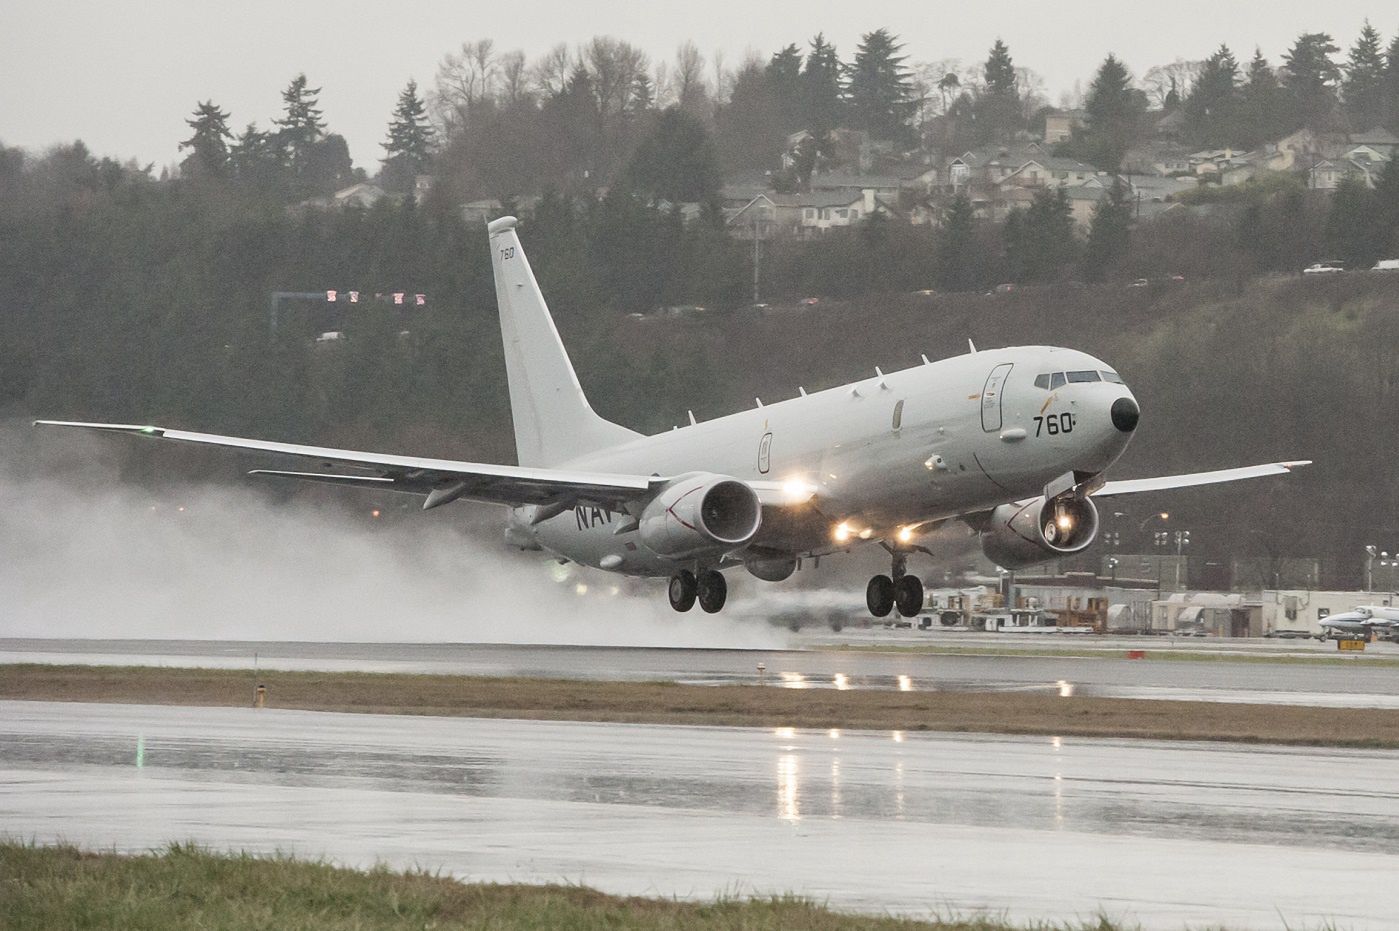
[[36, 217, 1307, 617]]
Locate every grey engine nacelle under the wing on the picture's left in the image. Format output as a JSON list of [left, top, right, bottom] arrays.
[[637, 472, 762, 559]]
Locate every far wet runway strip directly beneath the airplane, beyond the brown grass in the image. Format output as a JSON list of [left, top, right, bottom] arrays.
[[0, 636, 1399, 708]]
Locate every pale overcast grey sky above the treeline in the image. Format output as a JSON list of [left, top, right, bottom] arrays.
[[0, 0, 1399, 172]]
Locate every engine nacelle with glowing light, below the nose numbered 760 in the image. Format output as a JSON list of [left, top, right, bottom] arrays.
[[981, 494, 1098, 568]]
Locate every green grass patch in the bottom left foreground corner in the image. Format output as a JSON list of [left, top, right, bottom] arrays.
[[0, 843, 1121, 931]]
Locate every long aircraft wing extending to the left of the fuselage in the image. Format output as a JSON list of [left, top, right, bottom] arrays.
[[34, 420, 654, 508]]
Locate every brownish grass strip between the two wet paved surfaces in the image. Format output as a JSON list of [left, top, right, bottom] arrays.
[[0, 664, 1399, 748]]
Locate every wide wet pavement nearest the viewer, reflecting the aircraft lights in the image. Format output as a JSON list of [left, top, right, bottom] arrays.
[[0, 701, 1399, 931]]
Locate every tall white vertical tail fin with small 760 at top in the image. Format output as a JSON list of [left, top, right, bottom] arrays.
[[487, 217, 641, 466]]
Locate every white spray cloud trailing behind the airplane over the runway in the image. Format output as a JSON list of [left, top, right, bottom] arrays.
[[0, 424, 781, 648]]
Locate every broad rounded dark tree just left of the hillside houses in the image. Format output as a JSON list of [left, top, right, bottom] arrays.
[[625, 106, 720, 203]]
